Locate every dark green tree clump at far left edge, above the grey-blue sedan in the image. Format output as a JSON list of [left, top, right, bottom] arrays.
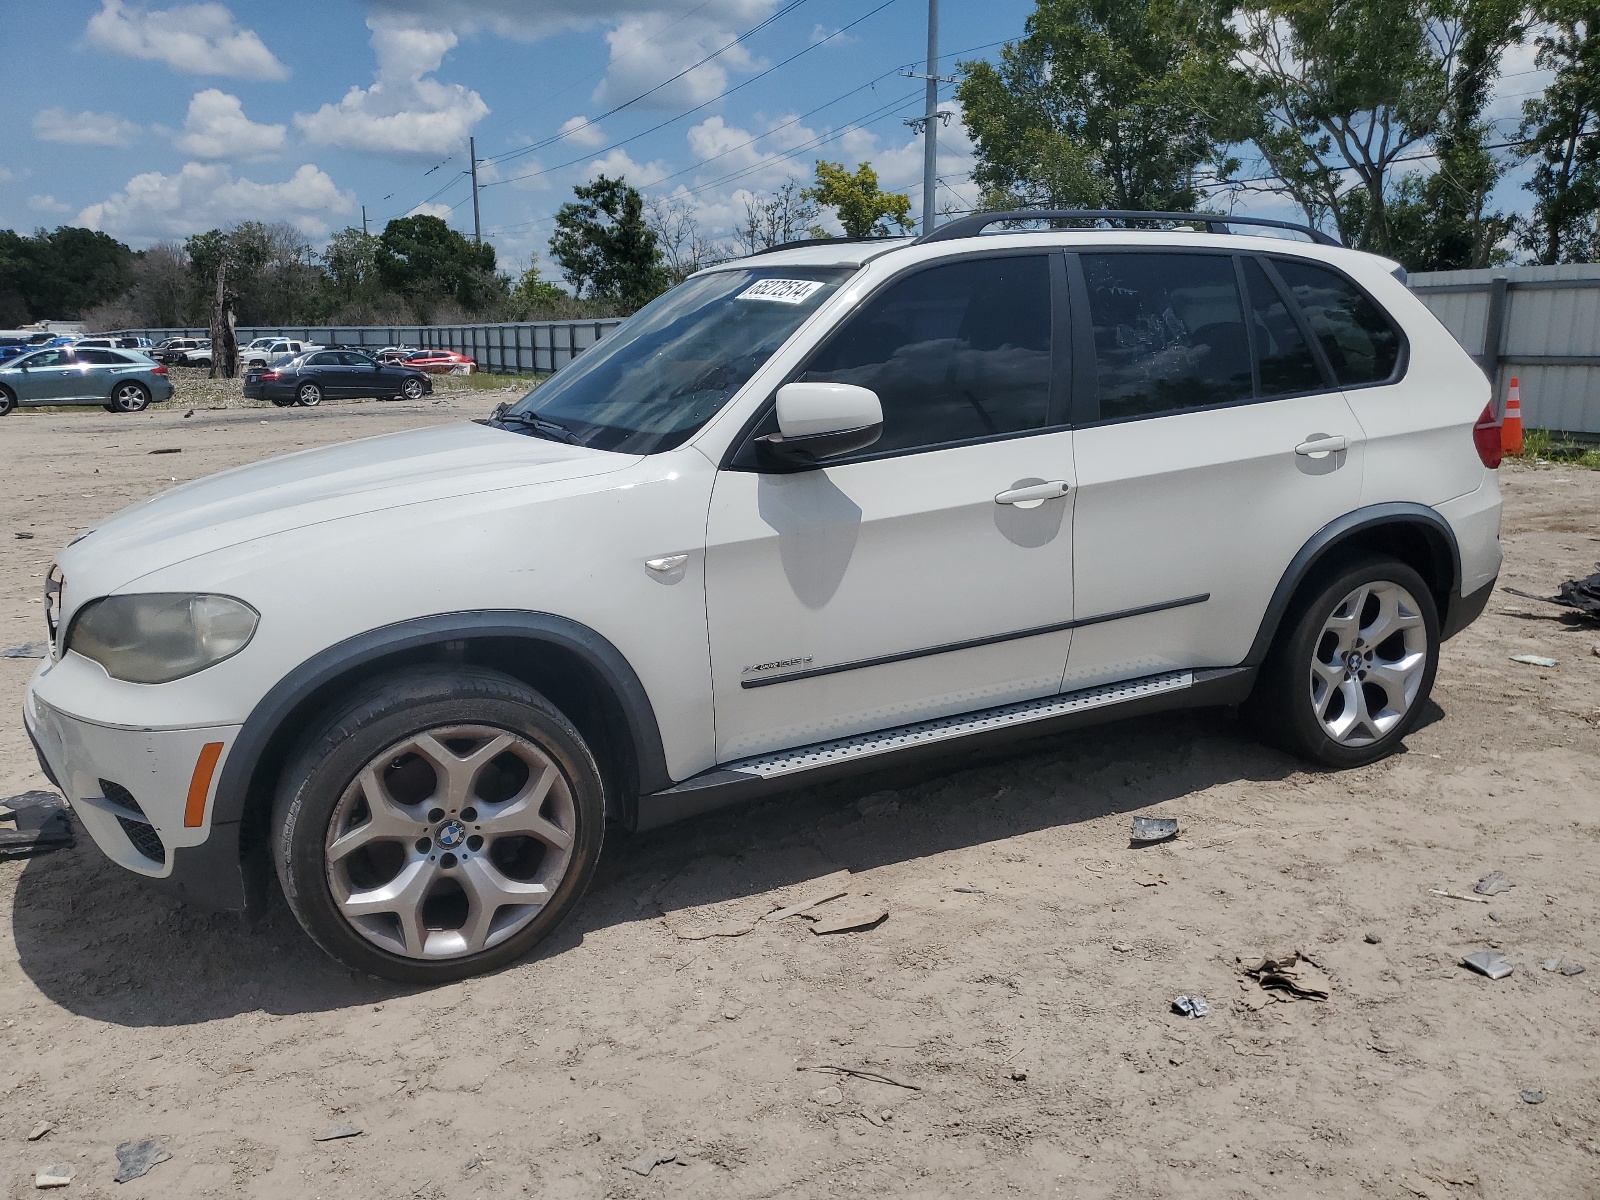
[[0, 226, 134, 325]]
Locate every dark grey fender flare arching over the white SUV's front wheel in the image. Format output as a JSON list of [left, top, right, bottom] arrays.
[[211, 610, 672, 826]]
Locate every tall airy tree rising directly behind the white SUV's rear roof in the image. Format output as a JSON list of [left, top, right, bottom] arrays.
[[1238, 0, 1523, 262]]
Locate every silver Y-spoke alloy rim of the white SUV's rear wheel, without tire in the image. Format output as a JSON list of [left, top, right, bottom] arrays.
[[1310, 581, 1429, 747]]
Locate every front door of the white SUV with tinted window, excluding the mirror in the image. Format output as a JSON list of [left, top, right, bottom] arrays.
[[706, 253, 1074, 762]]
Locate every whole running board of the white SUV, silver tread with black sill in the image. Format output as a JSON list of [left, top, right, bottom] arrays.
[[635, 667, 1256, 829]]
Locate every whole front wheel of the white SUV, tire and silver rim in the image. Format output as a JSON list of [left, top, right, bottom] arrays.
[[272, 667, 605, 984]]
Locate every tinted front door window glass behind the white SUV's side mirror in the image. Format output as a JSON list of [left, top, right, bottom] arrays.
[[802, 254, 1050, 453]]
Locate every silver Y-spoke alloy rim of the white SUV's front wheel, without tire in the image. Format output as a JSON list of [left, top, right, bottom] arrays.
[[323, 725, 578, 960]]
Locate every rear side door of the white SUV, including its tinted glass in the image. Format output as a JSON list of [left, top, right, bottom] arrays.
[[1066, 250, 1365, 688]]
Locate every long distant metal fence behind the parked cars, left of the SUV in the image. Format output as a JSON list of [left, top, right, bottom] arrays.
[[111, 318, 622, 374]]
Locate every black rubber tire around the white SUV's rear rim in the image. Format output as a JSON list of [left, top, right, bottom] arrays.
[[1242, 558, 1440, 770]]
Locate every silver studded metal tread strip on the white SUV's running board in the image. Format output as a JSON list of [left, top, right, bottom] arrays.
[[723, 670, 1194, 779]]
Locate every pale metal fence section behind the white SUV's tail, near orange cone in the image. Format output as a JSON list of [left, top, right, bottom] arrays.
[[1410, 262, 1600, 435]]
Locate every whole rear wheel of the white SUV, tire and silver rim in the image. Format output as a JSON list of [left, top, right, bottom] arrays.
[[1245, 560, 1440, 768]]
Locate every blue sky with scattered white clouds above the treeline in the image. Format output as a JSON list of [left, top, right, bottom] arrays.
[[0, 0, 1542, 274]]
